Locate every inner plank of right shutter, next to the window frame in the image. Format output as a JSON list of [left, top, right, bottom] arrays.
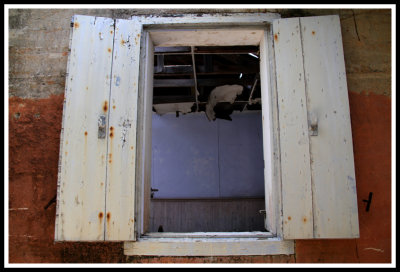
[[273, 18, 313, 239]]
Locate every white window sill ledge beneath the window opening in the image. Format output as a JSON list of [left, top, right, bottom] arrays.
[[124, 235, 294, 256]]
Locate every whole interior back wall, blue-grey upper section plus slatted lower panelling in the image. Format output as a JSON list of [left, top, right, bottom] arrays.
[[150, 111, 265, 232]]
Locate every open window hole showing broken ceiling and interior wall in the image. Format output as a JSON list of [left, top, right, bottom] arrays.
[[149, 46, 266, 232]]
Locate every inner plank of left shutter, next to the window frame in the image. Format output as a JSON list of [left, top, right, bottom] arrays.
[[105, 20, 141, 241]]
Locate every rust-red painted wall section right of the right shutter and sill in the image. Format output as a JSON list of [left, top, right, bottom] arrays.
[[296, 93, 391, 263]]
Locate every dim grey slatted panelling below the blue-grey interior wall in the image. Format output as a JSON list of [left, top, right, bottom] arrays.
[[149, 198, 265, 232]]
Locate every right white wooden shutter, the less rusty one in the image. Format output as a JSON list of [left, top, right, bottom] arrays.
[[273, 16, 359, 239]]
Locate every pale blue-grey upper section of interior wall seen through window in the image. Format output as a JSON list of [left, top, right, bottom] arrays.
[[151, 111, 264, 198]]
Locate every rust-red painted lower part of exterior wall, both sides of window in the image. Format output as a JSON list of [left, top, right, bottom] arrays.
[[9, 88, 391, 263]]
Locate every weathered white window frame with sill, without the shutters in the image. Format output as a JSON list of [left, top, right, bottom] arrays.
[[128, 13, 294, 256]]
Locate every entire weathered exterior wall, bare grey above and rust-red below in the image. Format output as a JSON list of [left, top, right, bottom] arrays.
[[8, 9, 391, 263]]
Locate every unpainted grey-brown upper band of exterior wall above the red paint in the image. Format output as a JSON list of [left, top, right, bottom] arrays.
[[8, 9, 391, 98]]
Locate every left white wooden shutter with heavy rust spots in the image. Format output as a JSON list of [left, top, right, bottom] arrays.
[[55, 15, 140, 241]]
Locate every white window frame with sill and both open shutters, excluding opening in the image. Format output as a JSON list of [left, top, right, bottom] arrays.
[[55, 14, 359, 255]]
